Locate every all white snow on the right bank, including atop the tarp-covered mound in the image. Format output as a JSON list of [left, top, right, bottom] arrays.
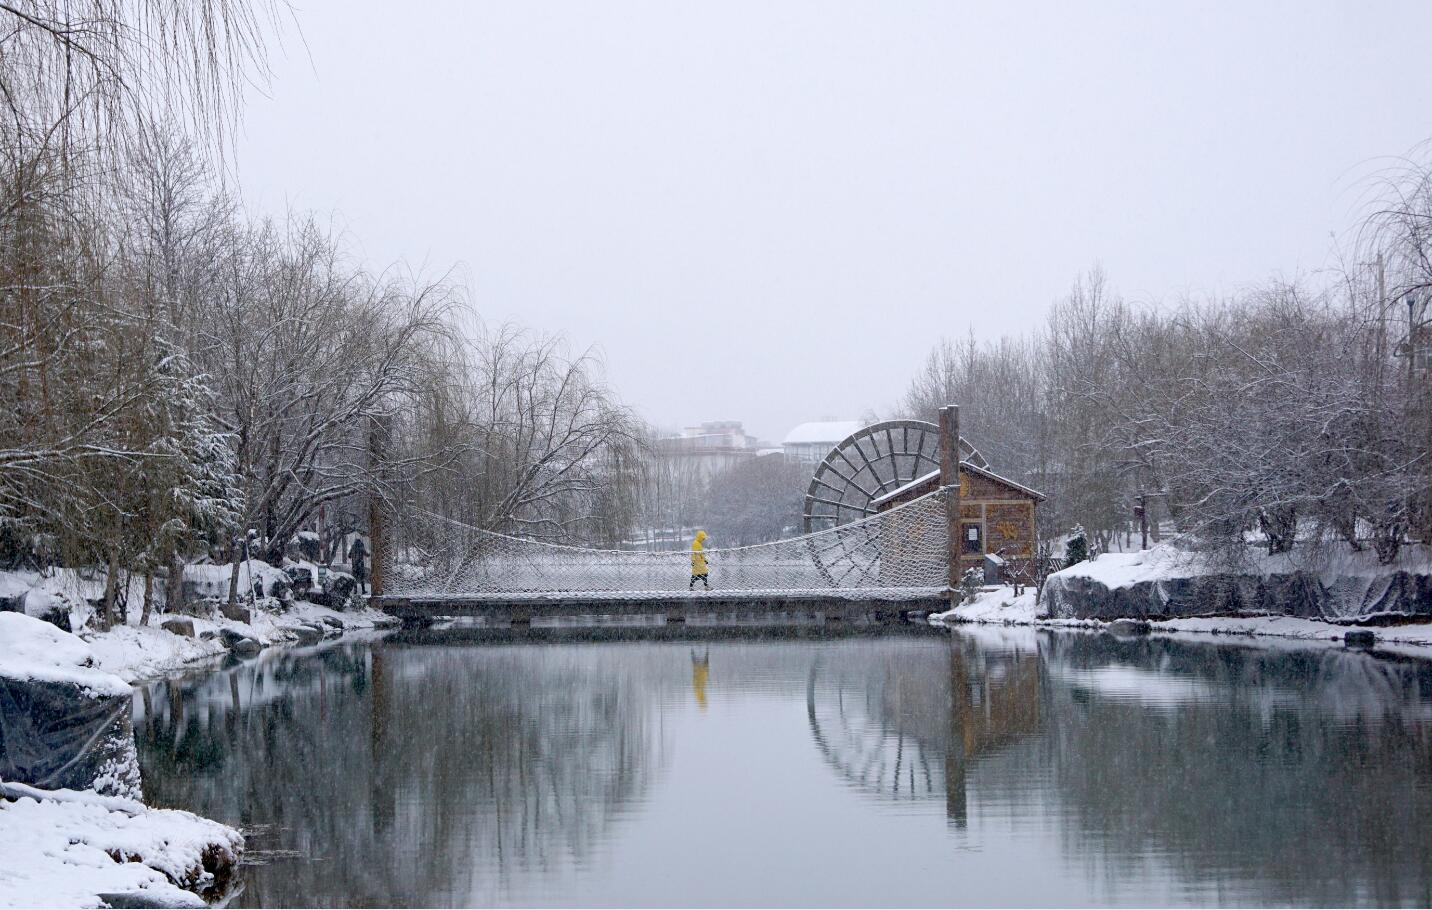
[[929, 547, 1432, 656]]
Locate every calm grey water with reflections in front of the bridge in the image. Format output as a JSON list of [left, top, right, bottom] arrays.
[[136, 626, 1432, 907]]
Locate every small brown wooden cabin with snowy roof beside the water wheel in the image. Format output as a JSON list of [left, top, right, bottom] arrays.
[[871, 461, 1045, 572]]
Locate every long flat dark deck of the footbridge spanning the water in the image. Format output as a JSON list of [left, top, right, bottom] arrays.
[[378, 588, 949, 618]]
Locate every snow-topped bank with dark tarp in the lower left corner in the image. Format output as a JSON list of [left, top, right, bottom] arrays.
[[0, 612, 243, 907]]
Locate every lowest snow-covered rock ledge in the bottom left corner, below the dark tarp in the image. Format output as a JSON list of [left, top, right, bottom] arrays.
[[0, 782, 243, 907]]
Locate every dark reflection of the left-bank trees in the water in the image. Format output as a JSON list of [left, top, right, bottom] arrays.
[[136, 642, 660, 906]]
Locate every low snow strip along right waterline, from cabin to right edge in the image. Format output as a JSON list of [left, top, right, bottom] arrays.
[[929, 587, 1432, 658]]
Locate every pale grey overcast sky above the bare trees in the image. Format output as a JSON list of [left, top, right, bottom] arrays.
[[238, 0, 1432, 440]]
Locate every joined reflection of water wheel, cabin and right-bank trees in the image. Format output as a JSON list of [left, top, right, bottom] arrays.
[[806, 629, 1432, 906]]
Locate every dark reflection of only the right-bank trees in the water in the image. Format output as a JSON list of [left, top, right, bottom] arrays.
[[1040, 635, 1432, 906]]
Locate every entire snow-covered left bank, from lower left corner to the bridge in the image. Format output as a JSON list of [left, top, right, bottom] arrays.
[[0, 573, 397, 909]]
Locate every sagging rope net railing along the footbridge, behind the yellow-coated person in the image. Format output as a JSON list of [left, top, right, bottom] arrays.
[[384, 490, 948, 600]]
